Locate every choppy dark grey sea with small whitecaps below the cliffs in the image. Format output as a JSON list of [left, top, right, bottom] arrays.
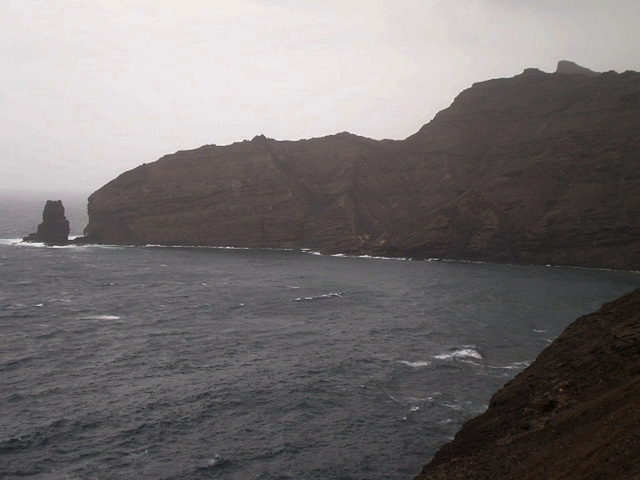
[[0, 193, 640, 480]]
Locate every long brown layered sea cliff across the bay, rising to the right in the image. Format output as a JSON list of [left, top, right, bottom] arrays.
[[86, 62, 640, 268]]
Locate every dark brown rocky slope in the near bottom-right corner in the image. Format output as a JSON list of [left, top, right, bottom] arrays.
[[416, 289, 640, 480]]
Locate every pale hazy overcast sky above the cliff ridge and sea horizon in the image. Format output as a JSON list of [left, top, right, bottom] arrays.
[[0, 0, 640, 194]]
